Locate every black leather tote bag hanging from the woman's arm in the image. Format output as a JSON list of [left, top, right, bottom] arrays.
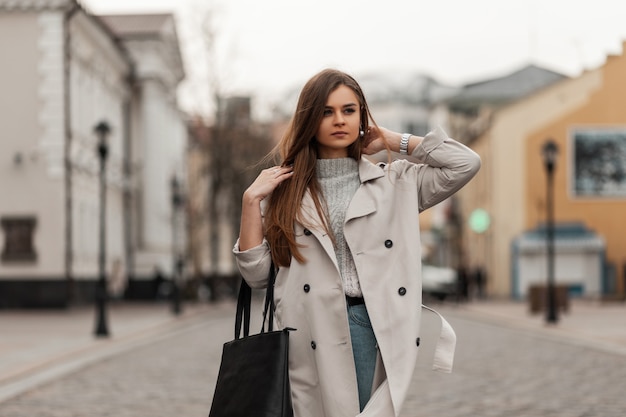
[[209, 265, 295, 417]]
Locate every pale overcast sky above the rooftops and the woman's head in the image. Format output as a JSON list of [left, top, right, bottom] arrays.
[[81, 0, 626, 117]]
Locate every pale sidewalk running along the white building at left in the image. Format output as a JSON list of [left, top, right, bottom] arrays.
[[0, 301, 235, 403]]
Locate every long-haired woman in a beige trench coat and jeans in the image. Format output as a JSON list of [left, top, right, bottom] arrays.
[[234, 69, 480, 417]]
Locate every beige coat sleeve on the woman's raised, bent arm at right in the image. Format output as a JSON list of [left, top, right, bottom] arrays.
[[404, 127, 481, 211]]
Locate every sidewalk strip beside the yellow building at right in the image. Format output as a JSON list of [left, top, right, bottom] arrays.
[[446, 299, 626, 355]]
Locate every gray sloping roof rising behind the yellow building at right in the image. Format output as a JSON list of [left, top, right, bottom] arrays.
[[448, 65, 567, 104]]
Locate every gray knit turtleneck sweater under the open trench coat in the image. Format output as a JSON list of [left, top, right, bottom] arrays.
[[317, 158, 363, 297]]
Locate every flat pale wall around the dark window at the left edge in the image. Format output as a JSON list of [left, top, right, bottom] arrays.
[[0, 12, 65, 279]]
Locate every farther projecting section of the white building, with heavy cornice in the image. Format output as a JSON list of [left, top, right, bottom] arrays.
[[98, 14, 188, 298]]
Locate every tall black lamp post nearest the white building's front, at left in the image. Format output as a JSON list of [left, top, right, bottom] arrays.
[[94, 121, 111, 337]]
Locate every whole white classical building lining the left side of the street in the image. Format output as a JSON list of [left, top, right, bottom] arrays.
[[0, 0, 186, 308]]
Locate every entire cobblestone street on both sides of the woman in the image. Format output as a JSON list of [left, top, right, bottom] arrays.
[[0, 306, 626, 417]]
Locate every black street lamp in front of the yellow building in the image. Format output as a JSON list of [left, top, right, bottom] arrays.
[[541, 139, 559, 323]]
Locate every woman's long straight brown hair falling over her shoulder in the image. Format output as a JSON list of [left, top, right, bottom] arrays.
[[264, 69, 374, 266]]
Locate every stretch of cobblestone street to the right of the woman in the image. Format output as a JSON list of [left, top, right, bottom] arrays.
[[403, 309, 626, 417]]
